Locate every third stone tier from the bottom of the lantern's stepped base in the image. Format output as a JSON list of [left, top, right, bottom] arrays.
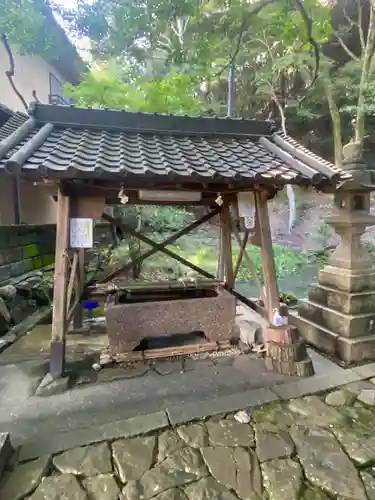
[[308, 283, 375, 314]]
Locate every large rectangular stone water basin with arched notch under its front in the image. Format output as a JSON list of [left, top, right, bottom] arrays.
[[105, 285, 236, 355]]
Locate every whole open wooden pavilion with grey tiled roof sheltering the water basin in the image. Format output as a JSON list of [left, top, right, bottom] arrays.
[[0, 103, 350, 377]]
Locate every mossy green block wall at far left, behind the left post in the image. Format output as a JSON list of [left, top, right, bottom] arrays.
[[0, 224, 56, 285]]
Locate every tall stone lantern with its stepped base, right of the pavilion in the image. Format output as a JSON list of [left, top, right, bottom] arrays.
[[291, 143, 375, 362]]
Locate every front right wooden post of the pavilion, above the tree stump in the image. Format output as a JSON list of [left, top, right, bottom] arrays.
[[254, 191, 280, 323]]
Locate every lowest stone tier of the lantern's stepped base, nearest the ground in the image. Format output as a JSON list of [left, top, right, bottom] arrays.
[[289, 311, 375, 363]]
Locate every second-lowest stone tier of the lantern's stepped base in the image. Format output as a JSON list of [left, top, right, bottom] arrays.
[[298, 299, 375, 338]]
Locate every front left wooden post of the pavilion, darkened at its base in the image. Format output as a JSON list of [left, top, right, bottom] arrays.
[[50, 188, 70, 378]]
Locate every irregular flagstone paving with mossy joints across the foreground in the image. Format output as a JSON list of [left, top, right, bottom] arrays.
[[0, 379, 375, 500]]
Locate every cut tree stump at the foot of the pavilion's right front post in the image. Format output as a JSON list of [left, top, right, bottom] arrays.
[[264, 326, 314, 377]]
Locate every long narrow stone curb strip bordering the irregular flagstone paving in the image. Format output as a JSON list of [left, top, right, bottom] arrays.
[[19, 363, 375, 462]]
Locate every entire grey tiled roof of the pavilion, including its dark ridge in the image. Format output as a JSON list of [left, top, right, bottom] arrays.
[[0, 104, 350, 185]]
